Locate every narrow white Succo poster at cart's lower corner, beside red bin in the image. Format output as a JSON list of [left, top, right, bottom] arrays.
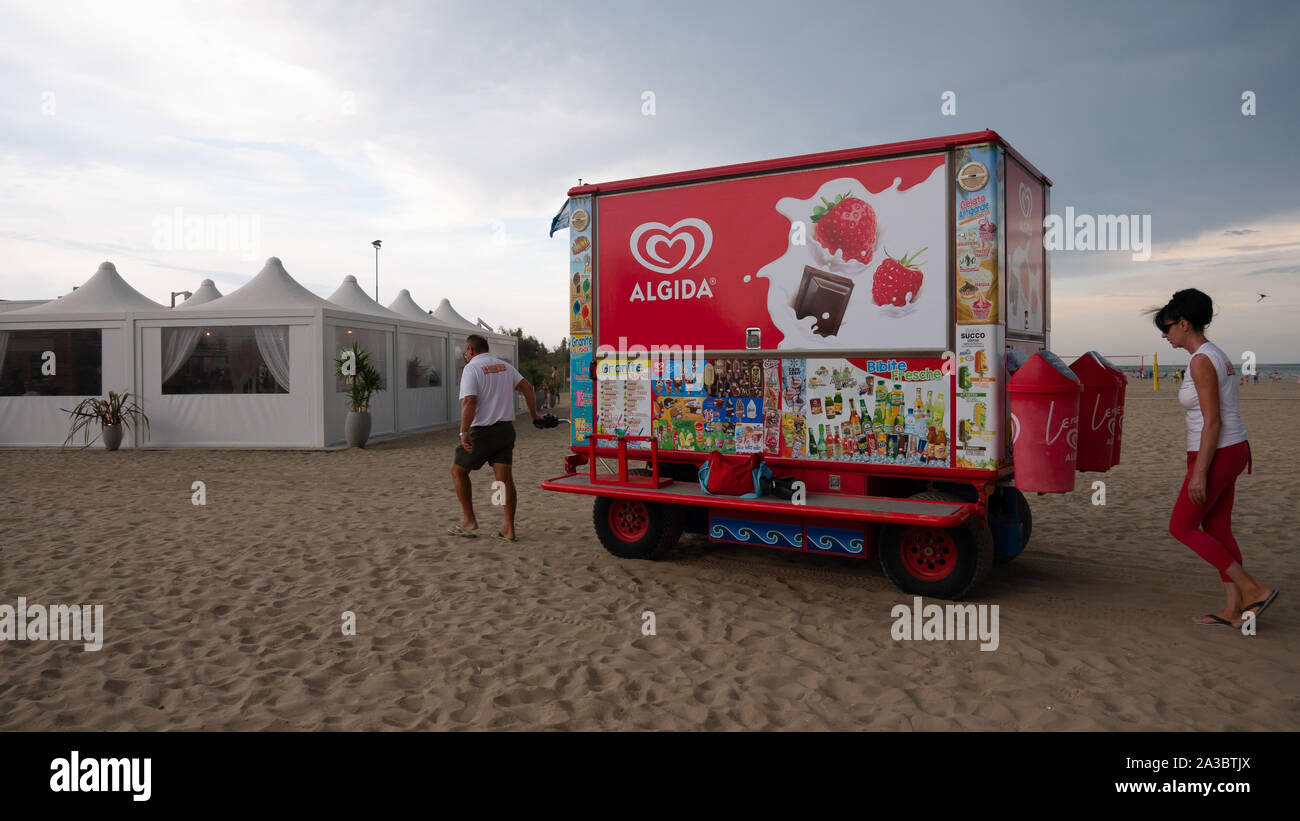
[[957, 325, 1006, 469]]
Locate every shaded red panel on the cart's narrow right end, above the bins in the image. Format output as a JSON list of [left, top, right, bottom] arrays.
[[1005, 157, 1047, 334]]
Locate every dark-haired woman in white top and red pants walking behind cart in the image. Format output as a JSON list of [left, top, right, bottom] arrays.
[[1153, 288, 1278, 627]]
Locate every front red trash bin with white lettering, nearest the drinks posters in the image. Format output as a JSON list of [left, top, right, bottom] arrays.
[[1006, 351, 1083, 494]]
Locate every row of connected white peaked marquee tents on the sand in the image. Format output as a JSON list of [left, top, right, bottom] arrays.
[[0, 257, 516, 448]]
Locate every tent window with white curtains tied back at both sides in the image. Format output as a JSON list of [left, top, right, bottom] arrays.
[[161, 325, 290, 395]]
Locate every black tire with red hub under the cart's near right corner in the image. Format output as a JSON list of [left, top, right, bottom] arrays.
[[878, 491, 995, 600]]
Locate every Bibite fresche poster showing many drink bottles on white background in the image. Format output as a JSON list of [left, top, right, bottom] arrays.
[[783, 357, 950, 466]]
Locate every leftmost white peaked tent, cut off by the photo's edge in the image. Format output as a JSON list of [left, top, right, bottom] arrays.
[[0, 262, 165, 446]]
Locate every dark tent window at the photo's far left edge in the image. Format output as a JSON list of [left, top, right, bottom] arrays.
[[0, 327, 101, 396]]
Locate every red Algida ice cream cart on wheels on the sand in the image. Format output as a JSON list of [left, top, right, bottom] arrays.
[[542, 131, 1123, 599]]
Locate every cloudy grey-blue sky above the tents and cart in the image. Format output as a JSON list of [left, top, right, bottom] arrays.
[[0, 0, 1300, 362]]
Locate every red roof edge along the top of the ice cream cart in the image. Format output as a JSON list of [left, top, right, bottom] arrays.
[[568, 130, 1052, 196]]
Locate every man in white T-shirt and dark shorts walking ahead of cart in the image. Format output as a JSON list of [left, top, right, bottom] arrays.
[[447, 334, 542, 542]]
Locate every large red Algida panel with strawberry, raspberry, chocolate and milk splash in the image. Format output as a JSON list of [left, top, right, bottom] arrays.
[[595, 153, 953, 353]]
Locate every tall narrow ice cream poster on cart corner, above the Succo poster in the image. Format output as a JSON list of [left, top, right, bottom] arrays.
[[954, 140, 1001, 325]]
